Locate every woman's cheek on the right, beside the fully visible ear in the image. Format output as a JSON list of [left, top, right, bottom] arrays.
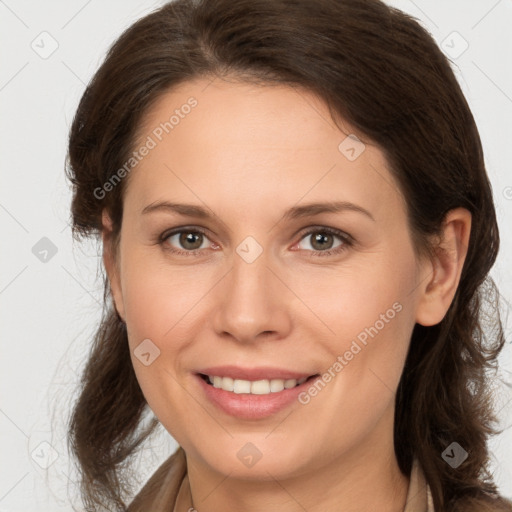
[[304, 251, 416, 388]]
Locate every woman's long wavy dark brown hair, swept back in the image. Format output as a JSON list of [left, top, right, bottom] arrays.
[[67, 0, 510, 512]]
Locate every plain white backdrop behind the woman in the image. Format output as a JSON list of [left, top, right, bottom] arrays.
[[0, 0, 512, 512]]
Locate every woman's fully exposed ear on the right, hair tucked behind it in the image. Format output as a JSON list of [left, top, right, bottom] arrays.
[[416, 208, 471, 326]]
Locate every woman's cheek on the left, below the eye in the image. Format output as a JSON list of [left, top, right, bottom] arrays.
[[122, 251, 200, 424]]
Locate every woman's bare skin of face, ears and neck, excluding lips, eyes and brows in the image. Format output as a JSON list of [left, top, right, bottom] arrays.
[[103, 79, 471, 512]]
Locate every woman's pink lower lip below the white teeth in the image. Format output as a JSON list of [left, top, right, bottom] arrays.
[[195, 374, 320, 420]]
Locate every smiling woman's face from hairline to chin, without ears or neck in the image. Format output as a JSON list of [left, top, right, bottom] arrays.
[[107, 76, 428, 479]]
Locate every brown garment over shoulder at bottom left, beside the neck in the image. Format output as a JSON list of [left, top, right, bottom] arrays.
[[127, 446, 187, 512]]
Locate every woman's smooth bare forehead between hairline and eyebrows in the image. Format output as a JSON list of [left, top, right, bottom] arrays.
[[126, 79, 402, 221]]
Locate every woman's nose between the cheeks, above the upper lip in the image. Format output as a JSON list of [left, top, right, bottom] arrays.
[[213, 247, 294, 344]]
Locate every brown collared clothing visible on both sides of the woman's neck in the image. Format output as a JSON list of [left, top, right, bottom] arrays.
[[127, 446, 434, 512]]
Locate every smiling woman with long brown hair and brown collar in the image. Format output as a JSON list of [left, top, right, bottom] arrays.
[[68, 0, 511, 512]]
